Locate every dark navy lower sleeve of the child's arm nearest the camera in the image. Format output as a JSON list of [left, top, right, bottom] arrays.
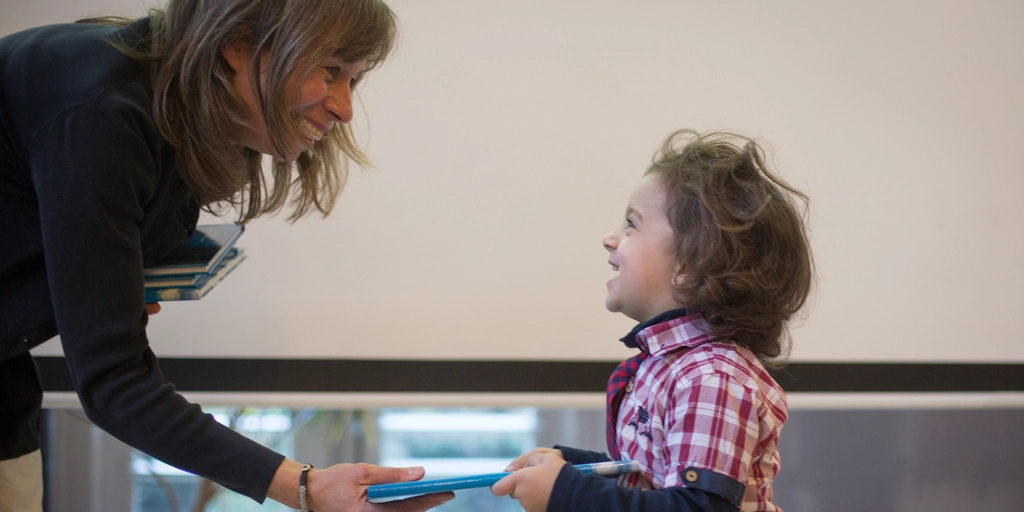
[[547, 464, 739, 512]]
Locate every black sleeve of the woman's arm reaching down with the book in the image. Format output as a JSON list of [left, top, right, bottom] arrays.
[[30, 105, 284, 503]]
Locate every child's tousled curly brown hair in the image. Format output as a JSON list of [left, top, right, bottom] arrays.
[[646, 130, 814, 367]]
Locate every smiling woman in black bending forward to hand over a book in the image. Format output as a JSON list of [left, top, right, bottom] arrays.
[[0, 0, 451, 512]]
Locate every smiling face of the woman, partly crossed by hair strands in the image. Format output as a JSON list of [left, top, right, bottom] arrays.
[[222, 43, 366, 162]]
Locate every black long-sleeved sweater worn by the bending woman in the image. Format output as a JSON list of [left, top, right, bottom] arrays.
[[0, 19, 284, 501]]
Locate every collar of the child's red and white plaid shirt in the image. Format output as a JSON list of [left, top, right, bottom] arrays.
[[620, 308, 722, 355]]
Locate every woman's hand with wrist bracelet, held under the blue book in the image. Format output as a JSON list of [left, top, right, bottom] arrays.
[[267, 459, 455, 512]]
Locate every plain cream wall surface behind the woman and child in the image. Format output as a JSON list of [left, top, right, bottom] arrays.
[[14, 0, 1024, 362]]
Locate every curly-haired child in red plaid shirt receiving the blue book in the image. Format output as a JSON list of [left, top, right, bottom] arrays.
[[492, 130, 813, 512]]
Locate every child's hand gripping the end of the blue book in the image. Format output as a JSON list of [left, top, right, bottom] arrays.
[[490, 449, 566, 512]]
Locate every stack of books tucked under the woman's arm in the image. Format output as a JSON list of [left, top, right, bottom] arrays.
[[142, 224, 246, 302]]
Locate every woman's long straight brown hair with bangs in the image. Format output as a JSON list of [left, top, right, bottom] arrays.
[[82, 0, 396, 221]]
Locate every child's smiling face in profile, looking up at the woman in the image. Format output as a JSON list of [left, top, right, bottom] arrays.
[[604, 175, 682, 322]]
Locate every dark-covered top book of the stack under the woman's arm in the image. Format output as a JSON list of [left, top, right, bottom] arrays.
[[142, 224, 245, 278]]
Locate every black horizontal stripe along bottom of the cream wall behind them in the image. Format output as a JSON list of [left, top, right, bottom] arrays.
[[36, 357, 1024, 393]]
